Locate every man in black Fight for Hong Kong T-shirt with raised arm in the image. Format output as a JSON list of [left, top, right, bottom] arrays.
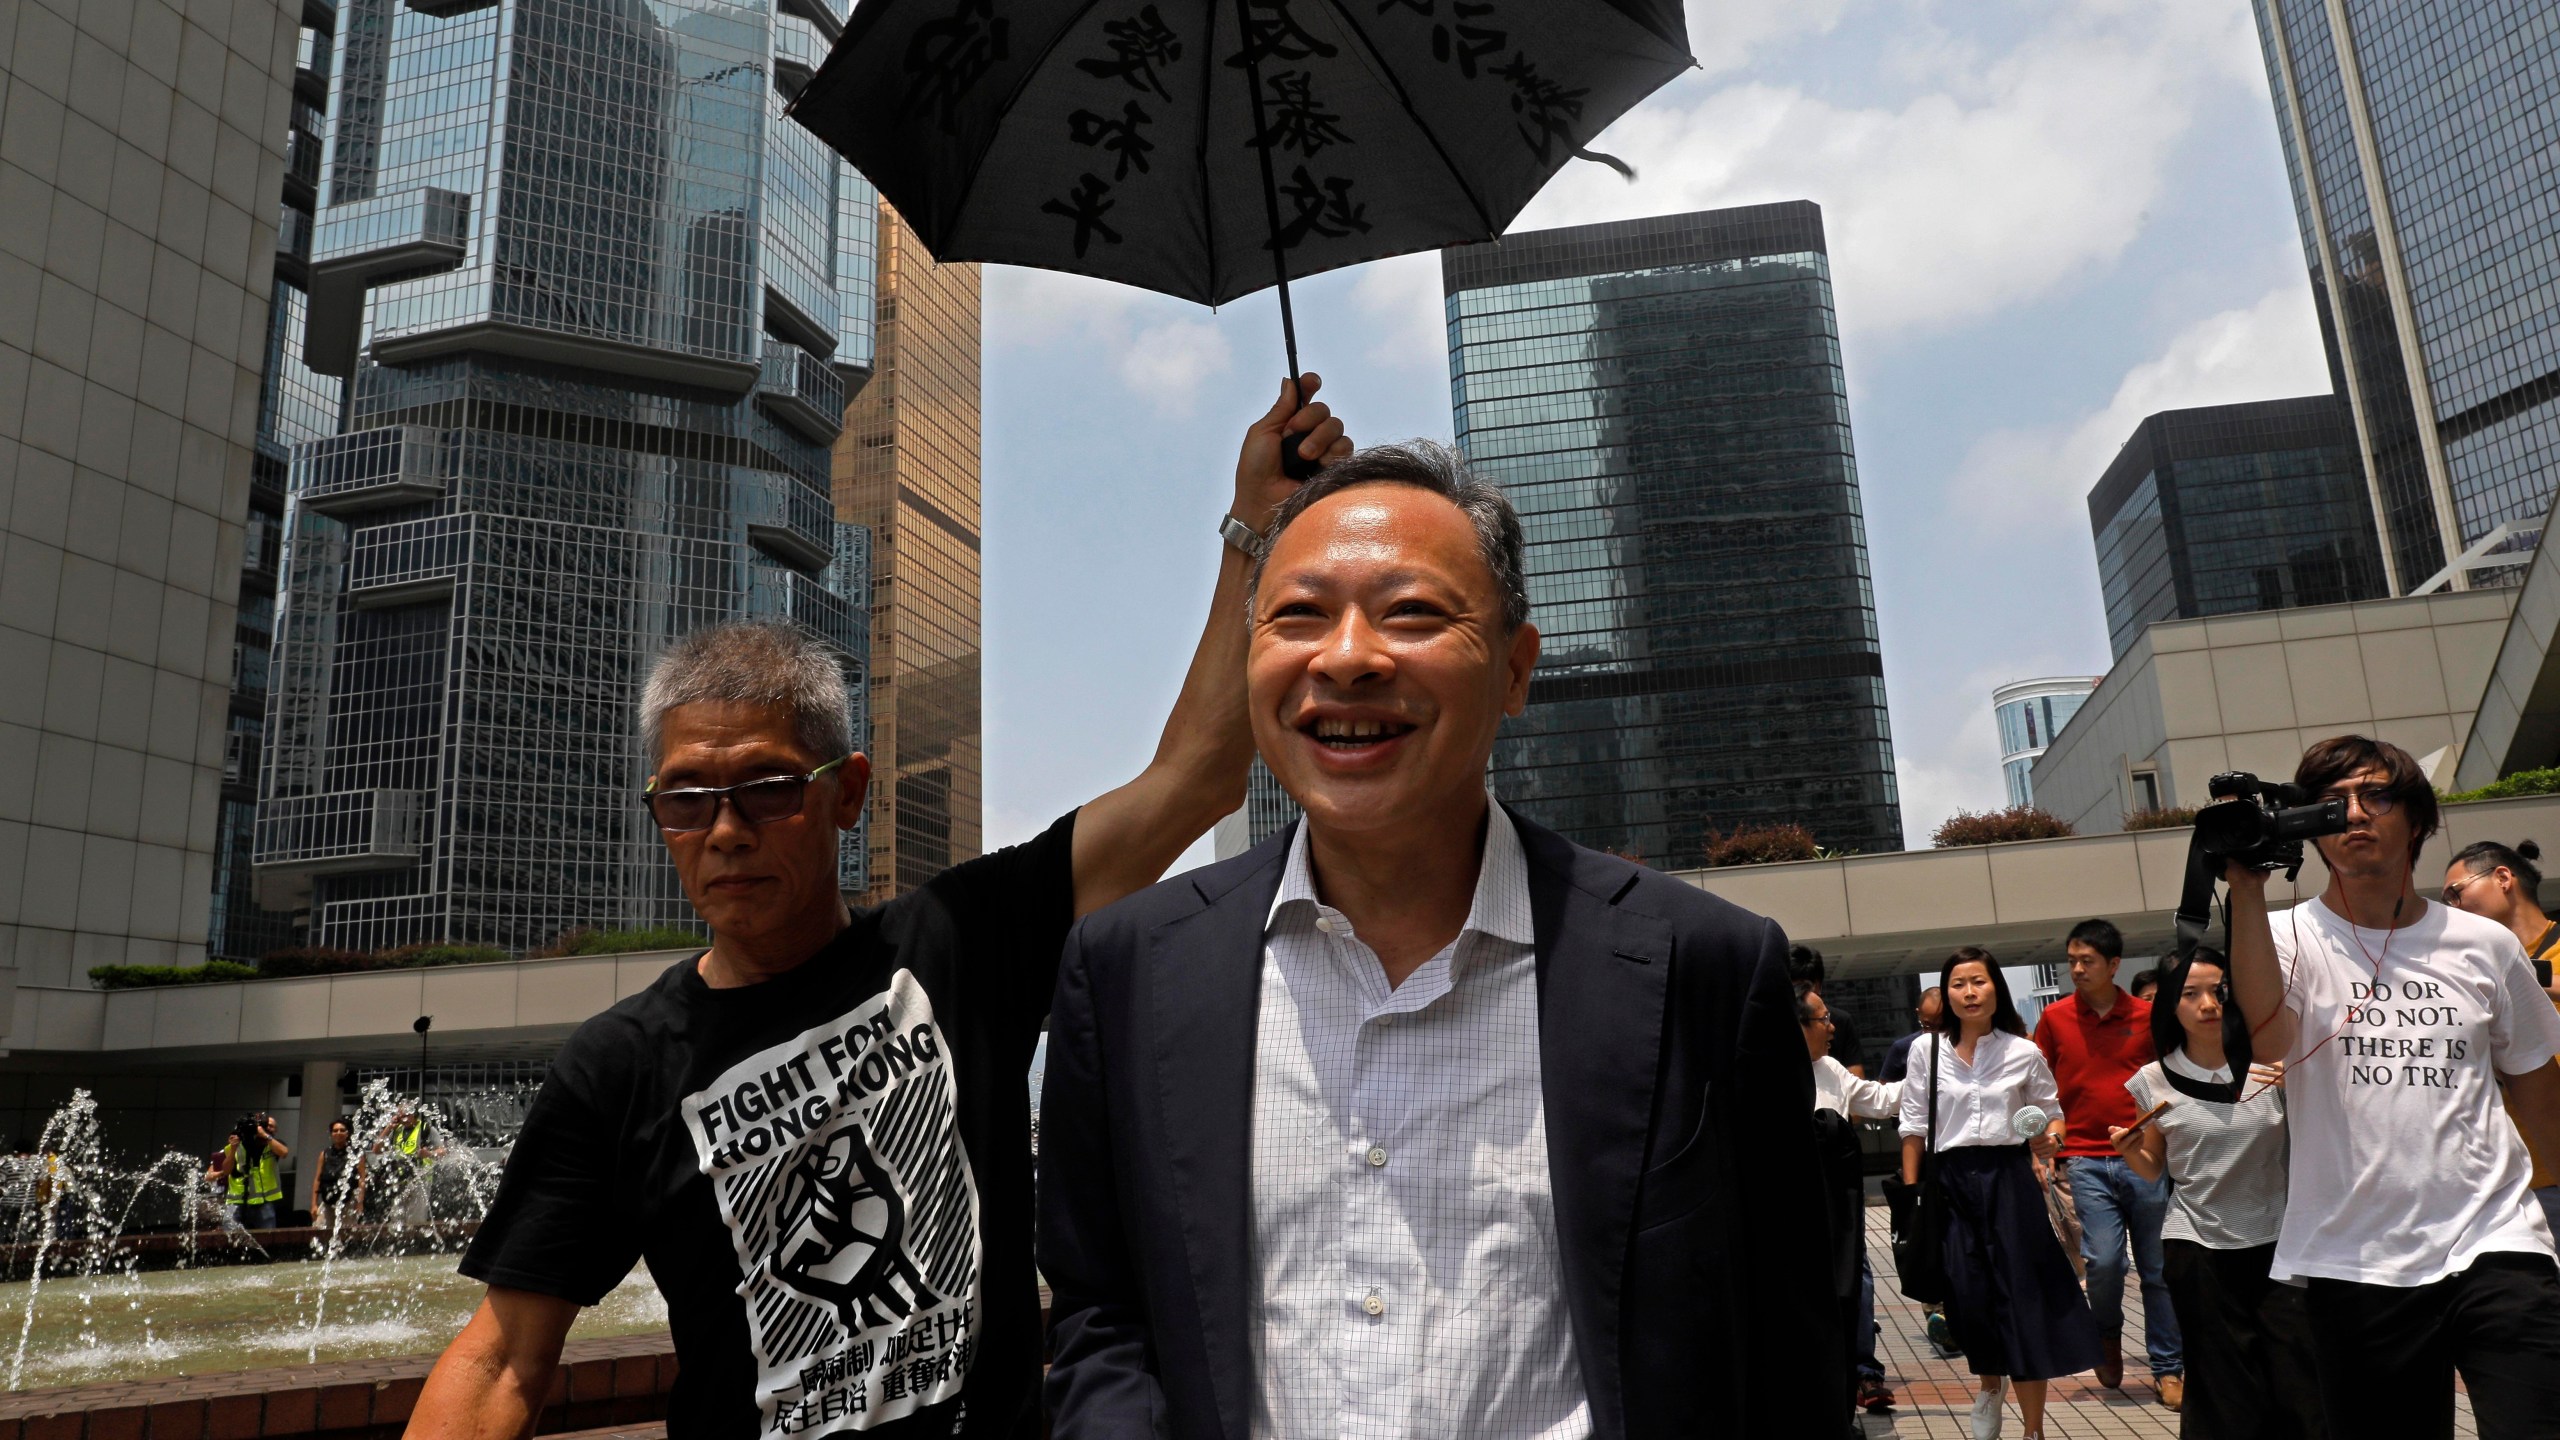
[[410, 374, 1352, 1440]]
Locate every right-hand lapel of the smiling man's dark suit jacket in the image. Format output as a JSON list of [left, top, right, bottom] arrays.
[[1513, 817, 1672, 1432]]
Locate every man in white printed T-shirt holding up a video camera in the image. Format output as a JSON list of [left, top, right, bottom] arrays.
[[2225, 735, 2560, 1440]]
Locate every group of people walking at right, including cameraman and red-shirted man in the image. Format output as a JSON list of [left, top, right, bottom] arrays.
[[1884, 735, 2560, 1440]]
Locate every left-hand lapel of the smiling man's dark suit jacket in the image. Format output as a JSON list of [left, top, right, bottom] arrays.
[[1147, 828, 1293, 1440]]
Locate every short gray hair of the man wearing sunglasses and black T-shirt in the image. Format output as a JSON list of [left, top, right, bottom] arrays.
[[640, 620, 852, 769]]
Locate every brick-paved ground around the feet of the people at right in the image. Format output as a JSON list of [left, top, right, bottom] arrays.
[[1864, 1204, 2478, 1440]]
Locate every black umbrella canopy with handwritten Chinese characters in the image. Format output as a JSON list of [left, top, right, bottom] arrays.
[[791, 0, 1695, 374]]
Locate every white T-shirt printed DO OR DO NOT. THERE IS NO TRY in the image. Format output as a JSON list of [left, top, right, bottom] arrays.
[[2271, 899, 2560, 1286]]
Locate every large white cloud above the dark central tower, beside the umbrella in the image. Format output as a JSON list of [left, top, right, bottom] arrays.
[[1521, 0, 2266, 338]]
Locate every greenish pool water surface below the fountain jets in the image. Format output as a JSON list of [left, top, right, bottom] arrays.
[[0, 1256, 666, 1389]]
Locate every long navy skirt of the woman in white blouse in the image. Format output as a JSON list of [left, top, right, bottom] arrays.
[[1935, 1145, 2099, 1381]]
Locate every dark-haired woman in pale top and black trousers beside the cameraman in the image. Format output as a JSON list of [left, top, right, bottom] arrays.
[[2107, 945, 2327, 1440]]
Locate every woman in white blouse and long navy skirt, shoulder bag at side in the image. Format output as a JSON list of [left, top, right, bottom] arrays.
[[1902, 945, 2099, 1440]]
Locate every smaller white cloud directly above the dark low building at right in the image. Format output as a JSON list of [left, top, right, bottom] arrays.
[[1948, 284, 2330, 543]]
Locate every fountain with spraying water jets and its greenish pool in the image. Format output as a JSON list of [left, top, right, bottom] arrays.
[[0, 1079, 666, 1391]]
